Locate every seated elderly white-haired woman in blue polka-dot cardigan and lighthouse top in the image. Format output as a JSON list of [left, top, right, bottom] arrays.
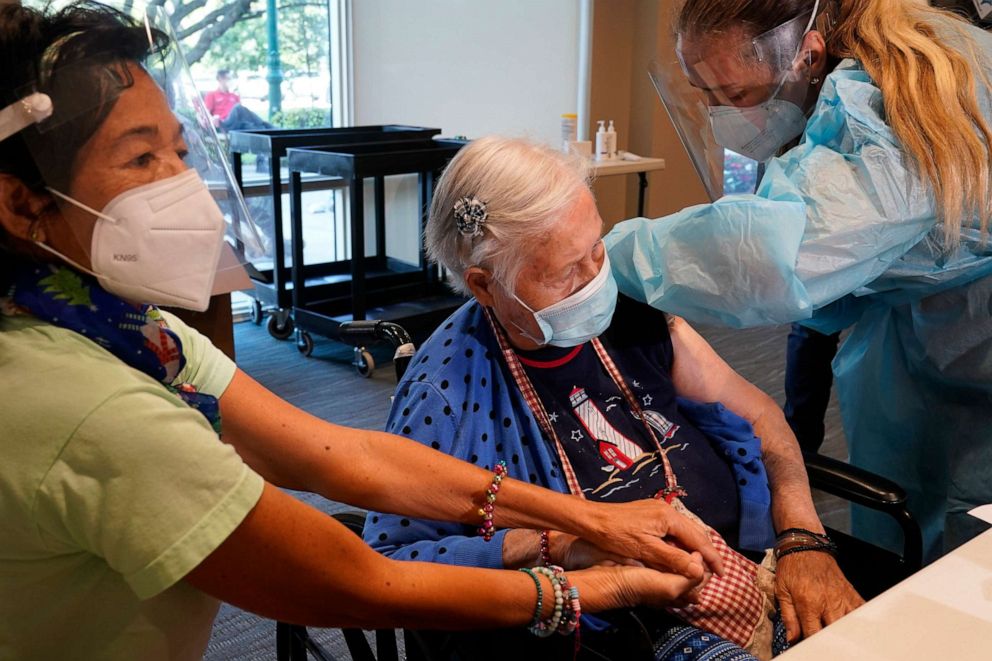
[[366, 137, 861, 658]]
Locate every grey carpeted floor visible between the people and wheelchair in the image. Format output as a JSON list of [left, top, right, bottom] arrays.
[[205, 322, 848, 661]]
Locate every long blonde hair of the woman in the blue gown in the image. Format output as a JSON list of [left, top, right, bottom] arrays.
[[675, 0, 992, 247]]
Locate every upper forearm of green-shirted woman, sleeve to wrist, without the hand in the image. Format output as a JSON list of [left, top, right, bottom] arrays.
[[221, 371, 610, 535]]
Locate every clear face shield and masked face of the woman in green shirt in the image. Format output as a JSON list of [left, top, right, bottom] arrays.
[[0, 2, 268, 310]]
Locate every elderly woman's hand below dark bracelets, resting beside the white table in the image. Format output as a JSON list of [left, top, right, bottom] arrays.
[[775, 551, 865, 642]]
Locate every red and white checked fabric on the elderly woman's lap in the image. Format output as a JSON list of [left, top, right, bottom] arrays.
[[667, 500, 764, 647]]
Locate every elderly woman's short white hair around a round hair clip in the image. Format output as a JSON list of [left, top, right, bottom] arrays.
[[425, 136, 590, 295]]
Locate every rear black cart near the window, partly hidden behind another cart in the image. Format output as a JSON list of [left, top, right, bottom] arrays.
[[229, 124, 441, 339]]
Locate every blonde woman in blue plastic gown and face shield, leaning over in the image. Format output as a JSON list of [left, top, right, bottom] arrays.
[[606, 0, 992, 559]]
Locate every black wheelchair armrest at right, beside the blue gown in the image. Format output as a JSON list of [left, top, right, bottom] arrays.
[[803, 452, 923, 569]]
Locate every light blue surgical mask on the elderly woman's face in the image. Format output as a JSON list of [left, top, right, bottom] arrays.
[[513, 253, 617, 347]]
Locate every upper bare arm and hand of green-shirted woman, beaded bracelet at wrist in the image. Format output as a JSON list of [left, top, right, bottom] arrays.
[[220, 370, 722, 577]]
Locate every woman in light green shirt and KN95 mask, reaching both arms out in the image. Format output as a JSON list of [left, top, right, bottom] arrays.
[[0, 4, 722, 659]]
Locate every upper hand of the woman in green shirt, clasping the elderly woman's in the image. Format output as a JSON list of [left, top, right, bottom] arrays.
[[583, 499, 723, 579]]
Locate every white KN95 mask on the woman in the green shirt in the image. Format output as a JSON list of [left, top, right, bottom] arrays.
[[36, 170, 225, 311]]
